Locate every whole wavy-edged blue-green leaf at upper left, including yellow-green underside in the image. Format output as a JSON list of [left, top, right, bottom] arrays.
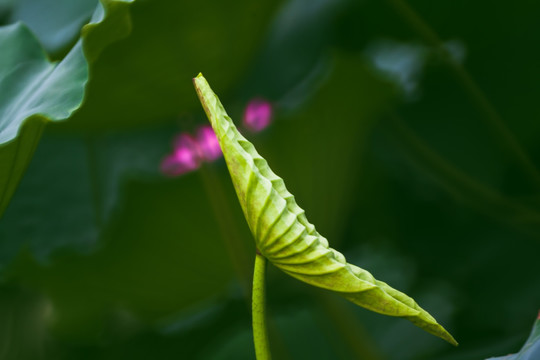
[[0, 0, 134, 216]]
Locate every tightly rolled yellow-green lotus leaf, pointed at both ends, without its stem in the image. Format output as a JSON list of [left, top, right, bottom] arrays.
[[193, 74, 457, 345]]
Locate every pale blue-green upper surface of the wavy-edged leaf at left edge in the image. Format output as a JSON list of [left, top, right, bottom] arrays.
[[0, 23, 88, 144]]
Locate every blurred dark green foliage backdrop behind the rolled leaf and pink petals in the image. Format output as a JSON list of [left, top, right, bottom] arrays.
[[0, 0, 540, 360]]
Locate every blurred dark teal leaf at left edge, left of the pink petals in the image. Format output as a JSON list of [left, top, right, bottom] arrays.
[[0, 127, 174, 269]]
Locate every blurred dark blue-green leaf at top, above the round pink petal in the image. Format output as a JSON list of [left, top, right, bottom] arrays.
[[238, 0, 347, 101]]
